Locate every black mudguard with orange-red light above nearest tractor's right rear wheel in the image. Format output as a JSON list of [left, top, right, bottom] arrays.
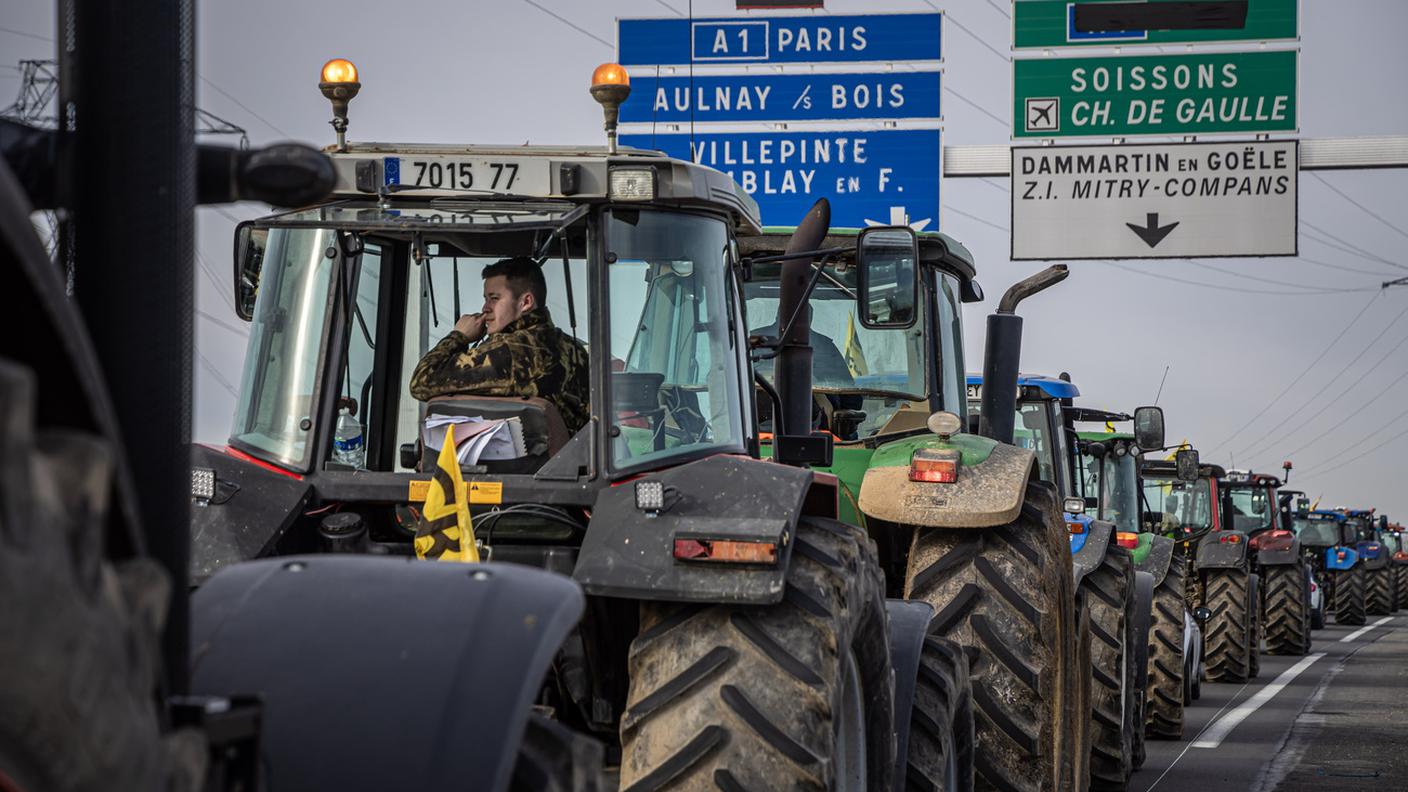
[[572, 455, 812, 605]]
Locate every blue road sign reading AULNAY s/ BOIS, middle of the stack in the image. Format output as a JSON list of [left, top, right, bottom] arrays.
[[621, 70, 941, 124]]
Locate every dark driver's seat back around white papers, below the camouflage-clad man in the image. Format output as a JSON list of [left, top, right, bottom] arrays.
[[420, 396, 570, 474]]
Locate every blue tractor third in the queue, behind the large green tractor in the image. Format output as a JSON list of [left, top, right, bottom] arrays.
[[967, 375, 1163, 789]]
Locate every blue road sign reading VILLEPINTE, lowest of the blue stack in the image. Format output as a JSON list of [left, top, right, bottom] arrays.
[[621, 130, 943, 231]]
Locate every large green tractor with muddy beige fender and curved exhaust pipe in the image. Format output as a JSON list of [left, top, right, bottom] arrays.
[[741, 230, 1090, 791]]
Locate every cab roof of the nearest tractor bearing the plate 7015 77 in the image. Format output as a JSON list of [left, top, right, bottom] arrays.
[[328, 142, 762, 234]]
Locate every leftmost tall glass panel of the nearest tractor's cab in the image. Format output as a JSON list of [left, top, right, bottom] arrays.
[[231, 228, 338, 471]]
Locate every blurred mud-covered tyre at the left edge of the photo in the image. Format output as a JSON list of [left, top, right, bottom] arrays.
[[0, 359, 181, 792]]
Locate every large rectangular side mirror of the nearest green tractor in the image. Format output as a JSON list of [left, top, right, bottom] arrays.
[[856, 225, 919, 328]]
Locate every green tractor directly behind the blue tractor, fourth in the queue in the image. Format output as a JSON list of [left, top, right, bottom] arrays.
[[1067, 419, 1202, 740]]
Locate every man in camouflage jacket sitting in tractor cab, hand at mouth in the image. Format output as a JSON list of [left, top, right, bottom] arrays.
[[411, 256, 590, 434]]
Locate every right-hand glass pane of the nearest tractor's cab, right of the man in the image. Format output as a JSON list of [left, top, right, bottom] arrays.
[[605, 209, 748, 469]]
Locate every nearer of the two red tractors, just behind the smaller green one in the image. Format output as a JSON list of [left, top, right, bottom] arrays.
[[1140, 459, 1262, 682]]
